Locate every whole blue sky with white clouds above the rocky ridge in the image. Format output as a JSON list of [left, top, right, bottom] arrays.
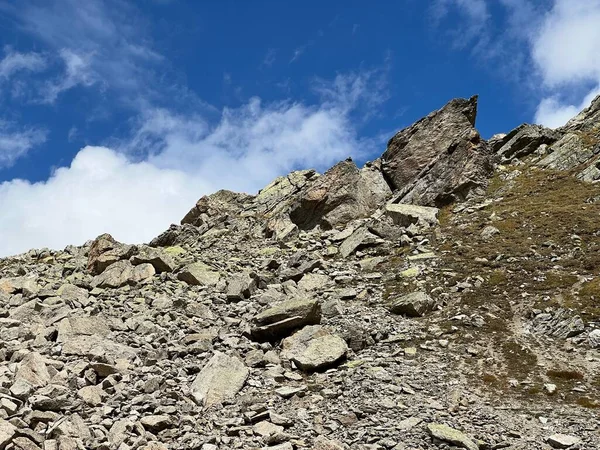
[[0, 0, 600, 255]]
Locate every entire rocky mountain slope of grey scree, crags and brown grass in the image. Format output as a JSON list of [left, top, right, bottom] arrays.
[[0, 97, 600, 450]]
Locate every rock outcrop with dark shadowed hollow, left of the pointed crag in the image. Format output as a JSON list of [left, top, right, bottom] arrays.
[[290, 159, 392, 229]]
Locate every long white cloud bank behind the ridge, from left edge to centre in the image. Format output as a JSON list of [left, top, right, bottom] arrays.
[[0, 68, 380, 255]]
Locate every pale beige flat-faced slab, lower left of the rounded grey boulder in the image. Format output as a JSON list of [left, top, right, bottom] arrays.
[[190, 352, 250, 407]]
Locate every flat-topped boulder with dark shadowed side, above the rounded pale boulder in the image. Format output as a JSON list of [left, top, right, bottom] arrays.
[[250, 298, 321, 340]]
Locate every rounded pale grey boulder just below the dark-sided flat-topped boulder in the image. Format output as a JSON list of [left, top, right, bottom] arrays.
[[281, 325, 348, 371]]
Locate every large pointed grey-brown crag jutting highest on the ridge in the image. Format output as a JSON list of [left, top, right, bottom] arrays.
[[382, 97, 493, 206]]
